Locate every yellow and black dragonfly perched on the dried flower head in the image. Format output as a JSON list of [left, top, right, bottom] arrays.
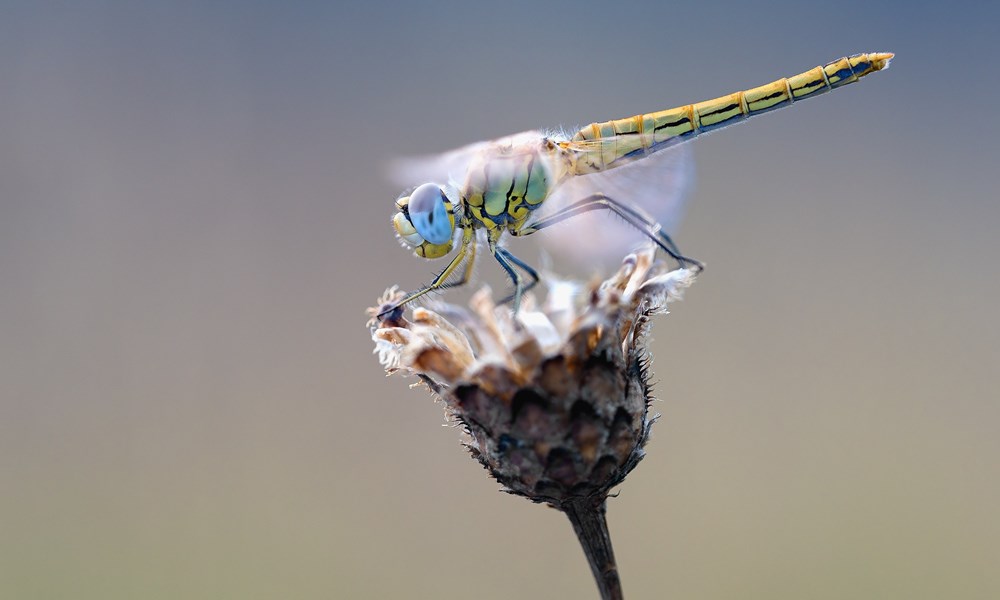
[[382, 52, 893, 315]]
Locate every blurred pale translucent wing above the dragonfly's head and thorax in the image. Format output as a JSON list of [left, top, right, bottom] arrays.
[[388, 131, 545, 187]]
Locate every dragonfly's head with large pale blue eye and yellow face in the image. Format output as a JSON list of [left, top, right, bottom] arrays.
[[392, 183, 455, 258]]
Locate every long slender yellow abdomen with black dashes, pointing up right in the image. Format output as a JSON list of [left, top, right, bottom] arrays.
[[571, 52, 893, 174]]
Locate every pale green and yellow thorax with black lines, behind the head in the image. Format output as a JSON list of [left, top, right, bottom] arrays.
[[463, 151, 552, 230]]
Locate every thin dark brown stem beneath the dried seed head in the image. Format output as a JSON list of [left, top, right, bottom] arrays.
[[560, 498, 623, 600]]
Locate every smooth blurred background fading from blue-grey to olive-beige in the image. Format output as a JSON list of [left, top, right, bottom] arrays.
[[0, 1, 1000, 599]]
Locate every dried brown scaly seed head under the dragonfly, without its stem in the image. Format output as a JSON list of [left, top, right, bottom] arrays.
[[369, 249, 694, 507]]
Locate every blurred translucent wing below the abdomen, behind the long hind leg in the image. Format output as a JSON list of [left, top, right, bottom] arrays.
[[532, 144, 694, 270]]
